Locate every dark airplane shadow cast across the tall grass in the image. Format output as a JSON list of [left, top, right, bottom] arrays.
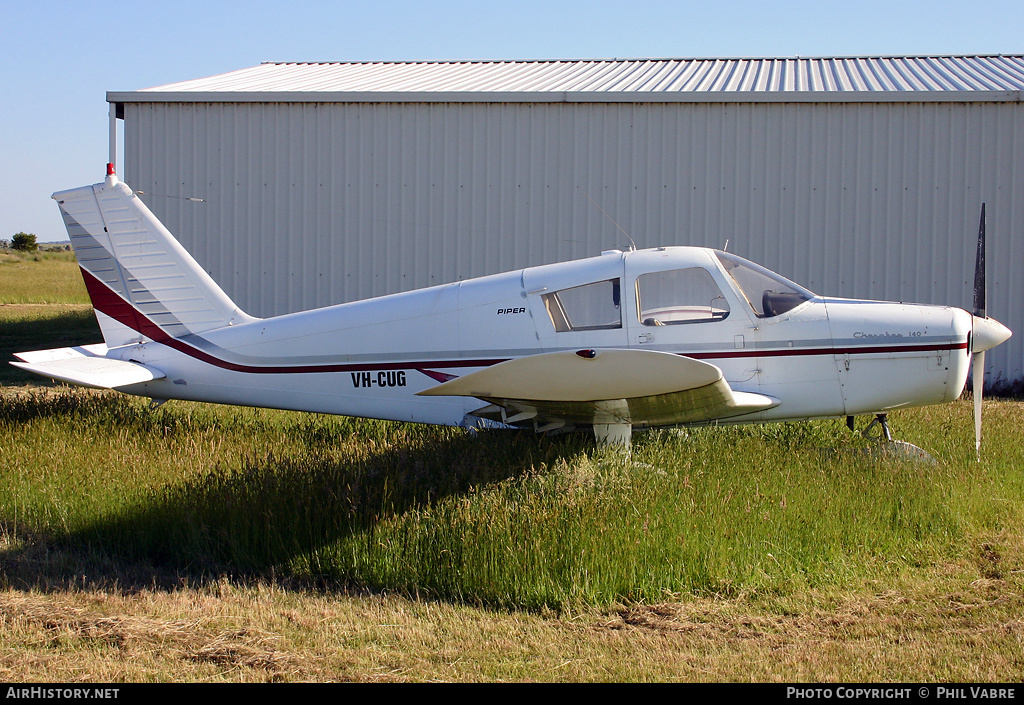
[[0, 398, 589, 590]]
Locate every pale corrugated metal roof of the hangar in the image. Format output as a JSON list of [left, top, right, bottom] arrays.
[[106, 55, 1024, 102]]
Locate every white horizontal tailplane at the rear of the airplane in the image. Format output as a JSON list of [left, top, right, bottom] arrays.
[[11, 344, 165, 389]]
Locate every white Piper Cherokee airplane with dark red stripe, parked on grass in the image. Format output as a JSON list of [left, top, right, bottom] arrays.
[[11, 168, 1011, 446]]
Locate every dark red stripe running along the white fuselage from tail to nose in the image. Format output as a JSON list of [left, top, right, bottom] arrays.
[[82, 268, 968, 374]]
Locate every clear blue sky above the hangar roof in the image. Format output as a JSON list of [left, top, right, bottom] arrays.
[[0, 0, 1024, 242]]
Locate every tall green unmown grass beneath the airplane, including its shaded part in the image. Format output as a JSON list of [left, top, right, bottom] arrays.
[[0, 391, 1024, 608]]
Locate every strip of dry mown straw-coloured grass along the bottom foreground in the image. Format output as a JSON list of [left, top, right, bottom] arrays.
[[0, 566, 1024, 682]]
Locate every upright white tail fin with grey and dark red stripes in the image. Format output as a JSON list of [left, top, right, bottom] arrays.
[[53, 175, 255, 347]]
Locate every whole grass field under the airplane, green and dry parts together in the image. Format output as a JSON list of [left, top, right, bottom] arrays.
[[0, 252, 1024, 681]]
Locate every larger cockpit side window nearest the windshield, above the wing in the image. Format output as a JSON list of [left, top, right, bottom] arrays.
[[637, 266, 729, 326]]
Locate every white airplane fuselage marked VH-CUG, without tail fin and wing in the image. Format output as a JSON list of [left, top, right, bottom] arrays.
[[108, 247, 972, 426]]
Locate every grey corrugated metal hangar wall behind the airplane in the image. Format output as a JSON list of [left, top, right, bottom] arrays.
[[125, 102, 1024, 379]]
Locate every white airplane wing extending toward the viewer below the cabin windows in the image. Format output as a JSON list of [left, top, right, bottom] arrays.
[[418, 349, 778, 430]]
